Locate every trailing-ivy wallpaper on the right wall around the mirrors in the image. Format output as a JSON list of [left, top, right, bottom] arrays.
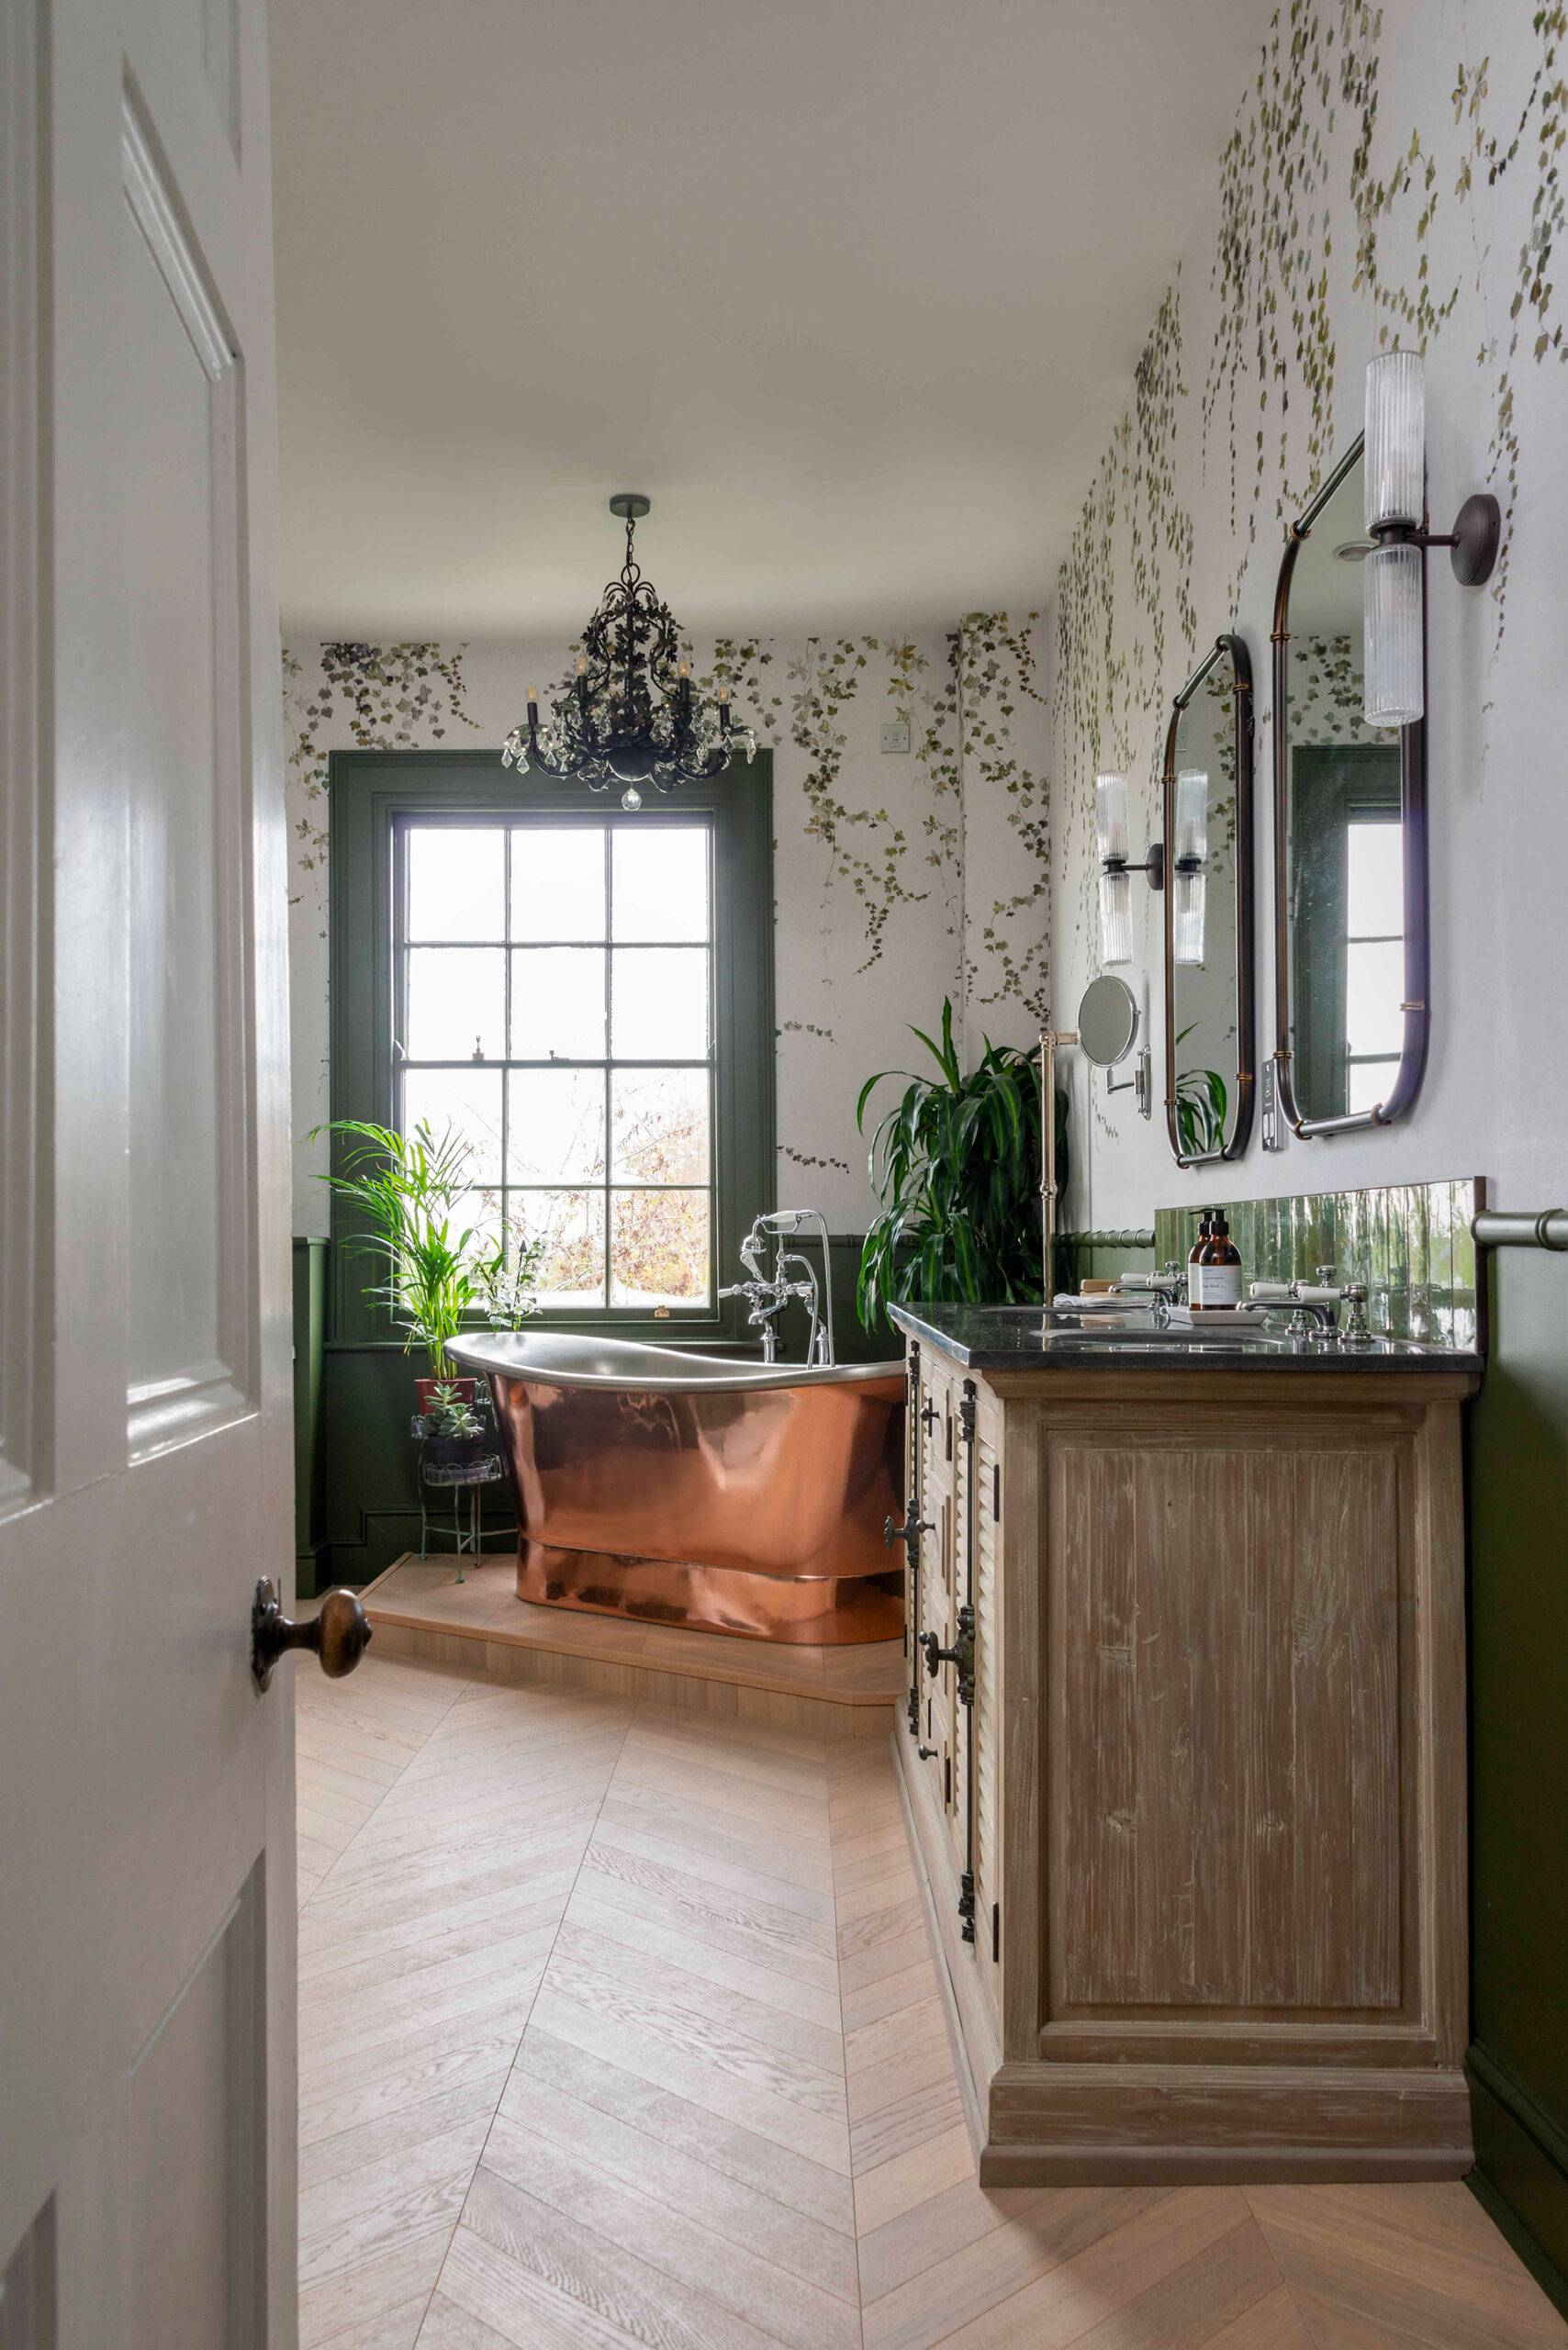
[[1047, 0, 1568, 1225]]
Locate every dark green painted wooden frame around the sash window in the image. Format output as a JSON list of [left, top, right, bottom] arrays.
[[327, 752, 776, 1348]]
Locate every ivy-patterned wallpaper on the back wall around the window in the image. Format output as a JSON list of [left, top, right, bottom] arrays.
[[282, 613, 1051, 1231]]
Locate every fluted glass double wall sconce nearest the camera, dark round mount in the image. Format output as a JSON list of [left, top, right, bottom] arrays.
[[1361, 350, 1502, 726]]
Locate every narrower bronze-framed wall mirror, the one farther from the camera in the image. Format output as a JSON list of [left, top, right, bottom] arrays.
[[1164, 637, 1258, 1168]]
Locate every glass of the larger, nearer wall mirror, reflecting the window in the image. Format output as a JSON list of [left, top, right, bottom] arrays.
[[1286, 458, 1406, 1121]]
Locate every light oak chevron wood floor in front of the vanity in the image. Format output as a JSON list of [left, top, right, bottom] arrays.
[[298, 1650, 1568, 2350]]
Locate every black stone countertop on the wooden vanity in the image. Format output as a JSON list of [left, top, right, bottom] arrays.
[[889, 1304, 1481, 1375]]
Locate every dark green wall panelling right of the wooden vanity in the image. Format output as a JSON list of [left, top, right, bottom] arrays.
[[1467, 1248, 1568, 2312]]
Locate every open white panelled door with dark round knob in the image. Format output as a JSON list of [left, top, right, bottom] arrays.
[[0, 0, 300, 2350]]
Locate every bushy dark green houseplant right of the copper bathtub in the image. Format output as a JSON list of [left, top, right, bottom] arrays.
[[856, 1002, 1068, 1330]]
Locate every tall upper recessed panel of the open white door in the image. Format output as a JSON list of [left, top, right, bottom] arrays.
[[120, 99, 249, 1457]]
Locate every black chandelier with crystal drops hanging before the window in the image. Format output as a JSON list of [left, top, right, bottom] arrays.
[[500, 488, 757, 809]]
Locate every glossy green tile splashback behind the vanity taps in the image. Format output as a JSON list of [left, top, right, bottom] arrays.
[[1154, 1182, 1485, 1351]]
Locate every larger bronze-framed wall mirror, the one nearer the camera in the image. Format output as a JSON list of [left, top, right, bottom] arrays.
[[1274, 440, 1429, 1135]]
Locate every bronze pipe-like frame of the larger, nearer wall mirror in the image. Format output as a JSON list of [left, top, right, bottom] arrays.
[[1271, 432, 1431, 1142]]
